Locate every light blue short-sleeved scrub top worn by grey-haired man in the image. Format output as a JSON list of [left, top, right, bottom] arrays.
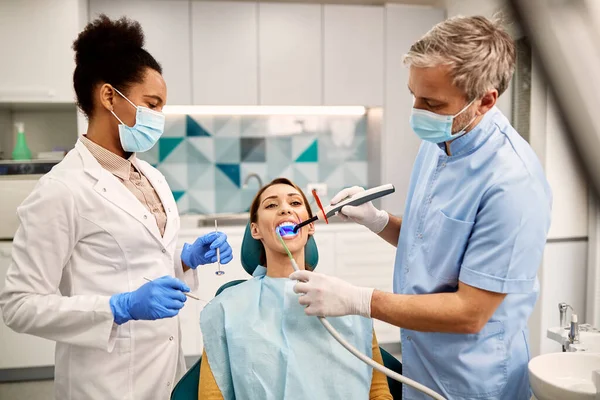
[[394, 108, 552, 400]]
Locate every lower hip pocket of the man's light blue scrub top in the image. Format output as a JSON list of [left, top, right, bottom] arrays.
[[434, 321, 508, 399]]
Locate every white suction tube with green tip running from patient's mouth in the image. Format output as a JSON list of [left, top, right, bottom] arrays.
[[277, 229, 446, 400]]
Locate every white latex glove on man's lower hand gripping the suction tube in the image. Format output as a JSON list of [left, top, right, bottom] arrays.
[[290, 270, 373, 318]]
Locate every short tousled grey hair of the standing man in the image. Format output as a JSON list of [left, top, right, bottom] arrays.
[[404, 16, 516, 99]]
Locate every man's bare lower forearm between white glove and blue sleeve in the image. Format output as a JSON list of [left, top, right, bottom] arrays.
[[371, 290, 481, 333]]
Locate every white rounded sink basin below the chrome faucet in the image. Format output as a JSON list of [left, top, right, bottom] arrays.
[[529, 352, 600, 400]]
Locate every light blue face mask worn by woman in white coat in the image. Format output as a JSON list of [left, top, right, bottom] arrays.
[[110, 88, 165, 153]]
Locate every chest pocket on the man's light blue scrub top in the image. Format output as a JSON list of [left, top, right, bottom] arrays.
[[424, 210, 473, 283]]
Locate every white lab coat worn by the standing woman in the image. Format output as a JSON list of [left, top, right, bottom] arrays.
[[0, 141, 198, 400]]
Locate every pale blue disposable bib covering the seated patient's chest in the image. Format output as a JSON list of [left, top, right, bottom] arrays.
[[200, 266, 373, 400]]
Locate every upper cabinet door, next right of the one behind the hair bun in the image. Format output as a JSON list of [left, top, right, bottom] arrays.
[[192, 1, 258, 105]]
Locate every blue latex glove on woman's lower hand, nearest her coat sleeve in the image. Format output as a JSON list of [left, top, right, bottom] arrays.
[[110, 275, 190, 325]]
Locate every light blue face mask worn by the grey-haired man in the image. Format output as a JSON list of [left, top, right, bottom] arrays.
[[410, 100, 477, 143]]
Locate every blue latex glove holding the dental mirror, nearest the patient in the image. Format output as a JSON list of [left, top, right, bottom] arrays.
[[181, 232, 233, 269]]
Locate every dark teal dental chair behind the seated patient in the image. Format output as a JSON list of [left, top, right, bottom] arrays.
[[171, 224, 402, 400]]
